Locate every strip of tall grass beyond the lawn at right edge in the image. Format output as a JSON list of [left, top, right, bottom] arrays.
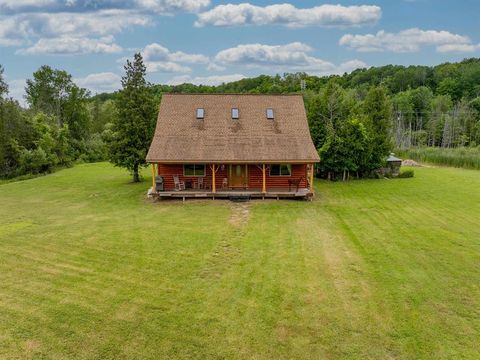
[[397, 146, 480, 170]]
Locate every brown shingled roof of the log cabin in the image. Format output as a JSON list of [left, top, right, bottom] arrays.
[[147, 94, 320, 162]]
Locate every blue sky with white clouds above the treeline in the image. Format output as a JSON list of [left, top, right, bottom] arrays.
[[0, 0, 480, 99]]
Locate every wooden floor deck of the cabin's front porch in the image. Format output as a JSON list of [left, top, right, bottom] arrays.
[[152, 188, 313, 200]]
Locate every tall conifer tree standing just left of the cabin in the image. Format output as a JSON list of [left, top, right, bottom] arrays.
[[108, 53, 156, 182]]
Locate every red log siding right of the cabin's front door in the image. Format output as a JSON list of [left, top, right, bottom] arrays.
[[248, 164, 307, 191]]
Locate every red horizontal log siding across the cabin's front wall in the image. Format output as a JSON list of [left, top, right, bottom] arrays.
[[158, 164, 307, 191]]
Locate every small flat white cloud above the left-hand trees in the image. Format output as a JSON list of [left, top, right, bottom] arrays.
[[16, 36, 122, 55]]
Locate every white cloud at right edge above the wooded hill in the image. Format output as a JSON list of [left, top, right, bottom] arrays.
[[340, 28, 473, 53]]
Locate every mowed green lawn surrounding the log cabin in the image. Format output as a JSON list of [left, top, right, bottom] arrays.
[[0, 164, 480, 359]]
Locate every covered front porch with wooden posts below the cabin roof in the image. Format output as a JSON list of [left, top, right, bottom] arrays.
[[149, 163, 314, 199]]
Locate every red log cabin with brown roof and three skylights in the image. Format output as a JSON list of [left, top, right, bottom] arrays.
[[147, 94, 320, 200]]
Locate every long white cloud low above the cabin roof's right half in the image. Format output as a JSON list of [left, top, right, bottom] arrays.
[[215, 42, 366, 75]]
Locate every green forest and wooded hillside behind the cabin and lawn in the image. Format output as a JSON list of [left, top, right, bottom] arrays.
[[0, 59, 480, 178]]
